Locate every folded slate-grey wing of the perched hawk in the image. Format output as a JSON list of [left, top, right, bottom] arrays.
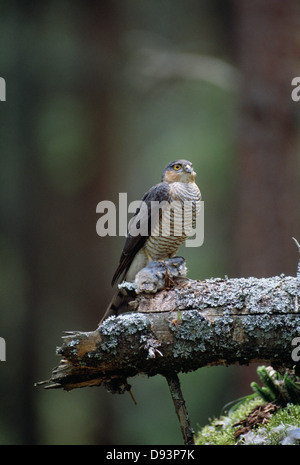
[[112, 182, 170, 285]]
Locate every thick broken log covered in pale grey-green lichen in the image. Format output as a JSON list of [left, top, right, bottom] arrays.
[[40, 275, 300, 392]]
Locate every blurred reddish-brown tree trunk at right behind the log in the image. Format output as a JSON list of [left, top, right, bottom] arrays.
[[234, 0, 299, 277]]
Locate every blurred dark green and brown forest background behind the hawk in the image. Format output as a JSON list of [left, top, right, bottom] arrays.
[[0, 0, 300, 445]]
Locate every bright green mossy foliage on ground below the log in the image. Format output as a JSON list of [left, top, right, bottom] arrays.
[[195, 366, 300, 445]]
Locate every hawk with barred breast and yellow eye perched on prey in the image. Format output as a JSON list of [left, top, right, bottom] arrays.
[[101, 160, 201, 322]]
